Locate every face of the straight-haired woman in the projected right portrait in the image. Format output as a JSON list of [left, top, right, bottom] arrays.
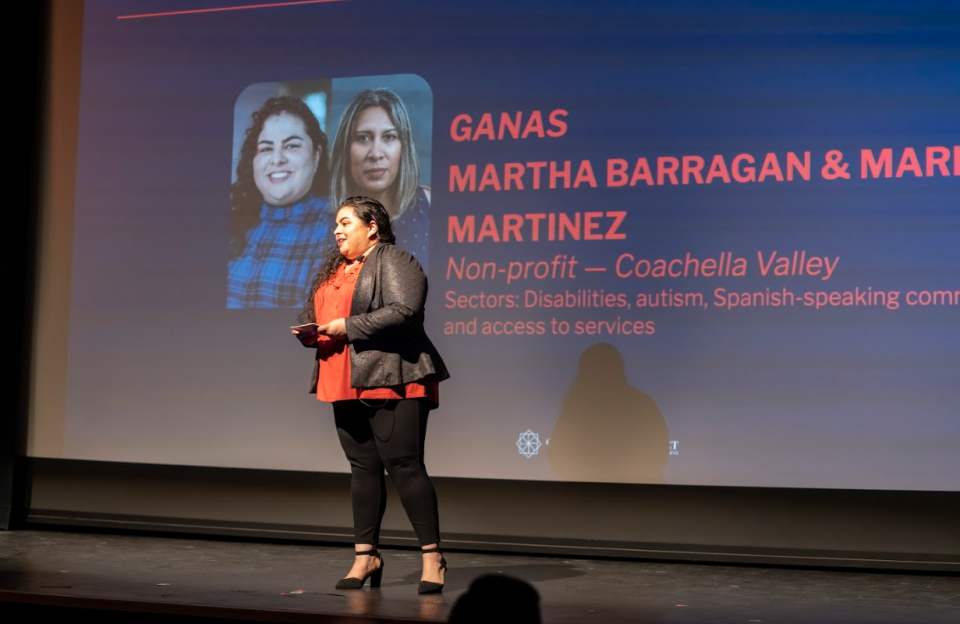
[[350, 106, 403, 197]]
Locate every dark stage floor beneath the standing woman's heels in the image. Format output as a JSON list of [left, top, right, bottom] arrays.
[[0, 530, 960, 624]]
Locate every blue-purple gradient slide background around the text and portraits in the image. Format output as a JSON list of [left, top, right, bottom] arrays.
[[67, 0, 960, 490]]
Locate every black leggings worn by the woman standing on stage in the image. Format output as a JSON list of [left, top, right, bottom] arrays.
[[333, 399, 440, 546]]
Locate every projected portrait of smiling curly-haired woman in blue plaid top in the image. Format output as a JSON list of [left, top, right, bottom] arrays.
[[227, 96, 330, 308]]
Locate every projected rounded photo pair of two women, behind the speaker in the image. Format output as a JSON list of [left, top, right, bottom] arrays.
[[227, 75, 433, 309]]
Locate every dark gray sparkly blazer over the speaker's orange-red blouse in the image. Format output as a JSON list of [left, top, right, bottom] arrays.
[[309, 243, 450, 394]]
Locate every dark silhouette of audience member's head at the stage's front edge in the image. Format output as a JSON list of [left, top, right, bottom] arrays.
[[447, 574, 540, 624]]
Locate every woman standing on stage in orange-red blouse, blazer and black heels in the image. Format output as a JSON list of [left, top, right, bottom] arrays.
[[293, 197, 450, 593]]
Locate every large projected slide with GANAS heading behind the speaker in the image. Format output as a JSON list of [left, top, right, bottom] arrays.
[[63, 0, 960, 490]]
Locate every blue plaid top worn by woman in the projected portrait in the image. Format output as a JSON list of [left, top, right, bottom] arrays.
[[227, 196, 333, 308]]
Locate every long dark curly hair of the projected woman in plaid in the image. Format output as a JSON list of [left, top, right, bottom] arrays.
[[230, 95, 330, 258]]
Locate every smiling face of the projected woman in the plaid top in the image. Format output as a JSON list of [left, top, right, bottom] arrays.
[[253, 113, 320, 206]]
